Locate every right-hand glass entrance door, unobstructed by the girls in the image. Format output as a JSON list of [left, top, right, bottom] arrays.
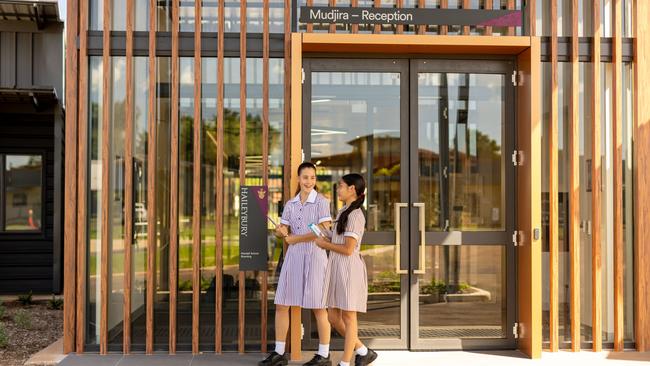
[[409, 60, 515, 349]]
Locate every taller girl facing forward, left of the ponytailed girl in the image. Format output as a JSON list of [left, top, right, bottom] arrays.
[[258, 162, 332, 366]]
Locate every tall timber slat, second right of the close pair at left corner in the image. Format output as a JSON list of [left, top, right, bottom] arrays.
[[122, 0, 135, 354]]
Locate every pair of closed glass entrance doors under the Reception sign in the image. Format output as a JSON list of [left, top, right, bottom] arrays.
[[303, 59, 516, 350]]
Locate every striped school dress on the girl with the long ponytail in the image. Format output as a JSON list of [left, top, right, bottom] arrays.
[[324, 207, 368, 313]]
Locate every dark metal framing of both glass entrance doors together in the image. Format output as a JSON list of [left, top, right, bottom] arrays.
[[302, 56, 517, 350]]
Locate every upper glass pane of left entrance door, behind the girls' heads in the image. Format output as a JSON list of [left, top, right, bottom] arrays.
[[311, 72, 401, 231]]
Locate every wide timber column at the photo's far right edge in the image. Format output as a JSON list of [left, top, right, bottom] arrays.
[[634, 0, 650, 352]]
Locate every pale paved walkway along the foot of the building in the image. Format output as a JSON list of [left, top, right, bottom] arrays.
[[59, 351, 650, 366]]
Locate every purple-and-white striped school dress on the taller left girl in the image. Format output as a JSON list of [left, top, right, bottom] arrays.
[[275, 190, 332, 309]]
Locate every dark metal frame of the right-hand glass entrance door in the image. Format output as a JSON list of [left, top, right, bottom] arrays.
[[409, 59, 517, 350]]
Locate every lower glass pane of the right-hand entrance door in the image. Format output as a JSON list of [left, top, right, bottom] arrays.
[[418, 245, 507, 339]]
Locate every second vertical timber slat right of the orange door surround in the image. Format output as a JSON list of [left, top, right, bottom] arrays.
[[569, 0, 580, 352]]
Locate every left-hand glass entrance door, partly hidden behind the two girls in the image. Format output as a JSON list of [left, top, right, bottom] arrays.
[[303, 59, 409, 349]]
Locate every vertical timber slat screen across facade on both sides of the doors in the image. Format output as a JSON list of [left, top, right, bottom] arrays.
[[58, 0, 650, 357]]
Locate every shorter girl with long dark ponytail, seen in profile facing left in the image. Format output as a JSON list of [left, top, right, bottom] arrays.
[[316, 173, 377, 366]]
